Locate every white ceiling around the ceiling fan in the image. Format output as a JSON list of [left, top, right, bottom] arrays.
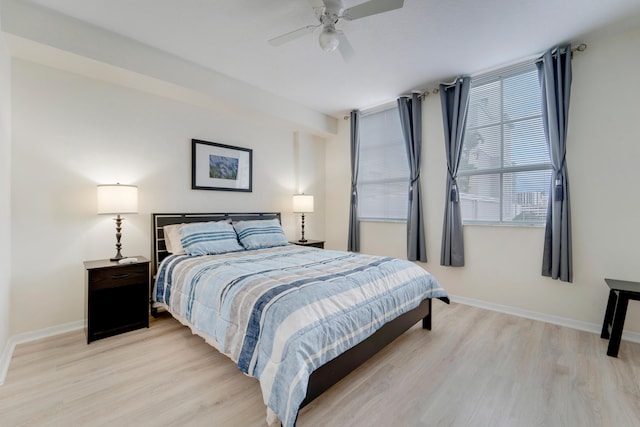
[[30, 0, 640, 117]]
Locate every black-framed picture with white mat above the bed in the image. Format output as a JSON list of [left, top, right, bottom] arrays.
[[191, 139, 253, 192]]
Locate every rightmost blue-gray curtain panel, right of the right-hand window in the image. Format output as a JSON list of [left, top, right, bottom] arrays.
[[537, 45, 573, 282]]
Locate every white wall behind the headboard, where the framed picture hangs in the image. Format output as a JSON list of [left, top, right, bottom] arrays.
[[11, 58, 324, 334]]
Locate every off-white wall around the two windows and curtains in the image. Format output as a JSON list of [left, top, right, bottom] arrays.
[[326, 29, 640, 332]]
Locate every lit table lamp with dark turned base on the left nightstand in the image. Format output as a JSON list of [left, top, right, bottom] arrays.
[[98, 184, 138, 261]]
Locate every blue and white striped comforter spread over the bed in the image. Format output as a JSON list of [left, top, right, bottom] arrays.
[[154, 245, 447, 427]]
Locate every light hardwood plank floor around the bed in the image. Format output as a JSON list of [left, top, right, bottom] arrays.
[[0, 301, 640, 427]]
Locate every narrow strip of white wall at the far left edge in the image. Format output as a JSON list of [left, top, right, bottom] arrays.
[[0, 9, 11, 362]]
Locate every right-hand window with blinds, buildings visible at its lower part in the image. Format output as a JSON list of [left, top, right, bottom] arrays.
[[457, 63, 551, 225]]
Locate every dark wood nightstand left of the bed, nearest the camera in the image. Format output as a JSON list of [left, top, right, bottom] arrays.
[[84, 256, 149, 344]]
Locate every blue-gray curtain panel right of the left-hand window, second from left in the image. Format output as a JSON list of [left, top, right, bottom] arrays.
[[398, 93, 427, 262]]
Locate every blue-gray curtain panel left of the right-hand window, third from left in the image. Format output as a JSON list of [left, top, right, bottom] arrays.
[[440, 77, 471, 267]]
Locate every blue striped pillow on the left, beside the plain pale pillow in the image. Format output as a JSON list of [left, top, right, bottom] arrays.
[[180, 221, 244, 255]]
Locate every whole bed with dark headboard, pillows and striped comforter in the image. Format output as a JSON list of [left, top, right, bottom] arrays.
[[151, 213, 449, 427]]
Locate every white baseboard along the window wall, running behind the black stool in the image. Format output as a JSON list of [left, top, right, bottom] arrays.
[[449, 295, 640, 343]]
